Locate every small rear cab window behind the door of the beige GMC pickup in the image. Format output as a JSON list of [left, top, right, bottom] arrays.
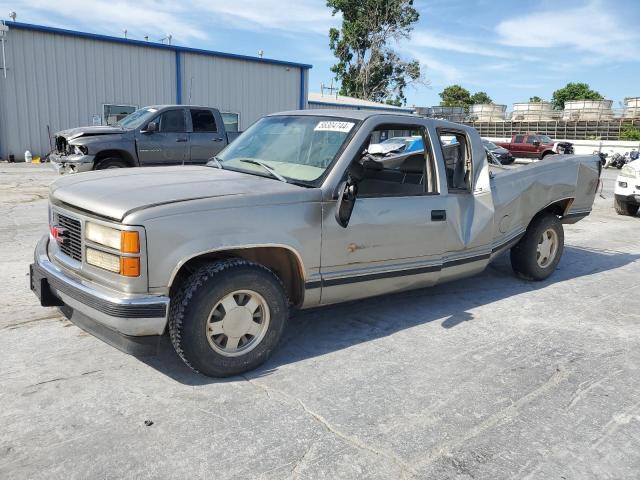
[[438, 129, 473, 193]]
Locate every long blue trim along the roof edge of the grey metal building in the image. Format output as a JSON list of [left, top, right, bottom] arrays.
[[5, 20, 313, 69]]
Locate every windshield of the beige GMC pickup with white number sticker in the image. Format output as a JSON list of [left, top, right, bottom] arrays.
[[217, 115, 356, 182]]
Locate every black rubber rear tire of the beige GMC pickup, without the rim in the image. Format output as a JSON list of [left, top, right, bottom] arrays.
[[511, 213, 564, 281]]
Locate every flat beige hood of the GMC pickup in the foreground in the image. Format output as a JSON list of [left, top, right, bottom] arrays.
[[50, 167, 304, 221]]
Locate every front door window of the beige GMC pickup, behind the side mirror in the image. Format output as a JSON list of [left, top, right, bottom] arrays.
[[358, 125, 437, 197]]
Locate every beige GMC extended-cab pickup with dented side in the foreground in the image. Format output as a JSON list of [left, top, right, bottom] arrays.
[[31, 110, 601, 376]]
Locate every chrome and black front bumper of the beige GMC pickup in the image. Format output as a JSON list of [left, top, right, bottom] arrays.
[[30, 236, 169, 355]]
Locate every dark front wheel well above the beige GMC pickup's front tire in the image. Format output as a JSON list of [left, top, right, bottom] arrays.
[[171, 247, 304, 306]]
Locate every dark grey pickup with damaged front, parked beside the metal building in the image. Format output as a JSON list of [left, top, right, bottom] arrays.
[[49, 105, 238, 173]]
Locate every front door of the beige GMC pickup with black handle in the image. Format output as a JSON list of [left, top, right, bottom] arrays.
[[321, 125, 447, 304]]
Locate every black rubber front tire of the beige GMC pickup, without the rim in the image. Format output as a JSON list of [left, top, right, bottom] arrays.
[[169, 258, 289, 377]]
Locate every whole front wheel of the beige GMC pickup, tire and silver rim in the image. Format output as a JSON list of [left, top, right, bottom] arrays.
[[169, 259, 289, 377]]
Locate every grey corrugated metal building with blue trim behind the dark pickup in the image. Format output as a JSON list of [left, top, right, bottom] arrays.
[[0, 22, 311, 160]]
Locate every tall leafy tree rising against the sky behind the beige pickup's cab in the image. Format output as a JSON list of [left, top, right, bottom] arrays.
[[327, 0, 422, 105]]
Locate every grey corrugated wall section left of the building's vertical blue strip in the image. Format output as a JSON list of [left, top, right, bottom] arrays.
[[0, 29, 176, 158]]
